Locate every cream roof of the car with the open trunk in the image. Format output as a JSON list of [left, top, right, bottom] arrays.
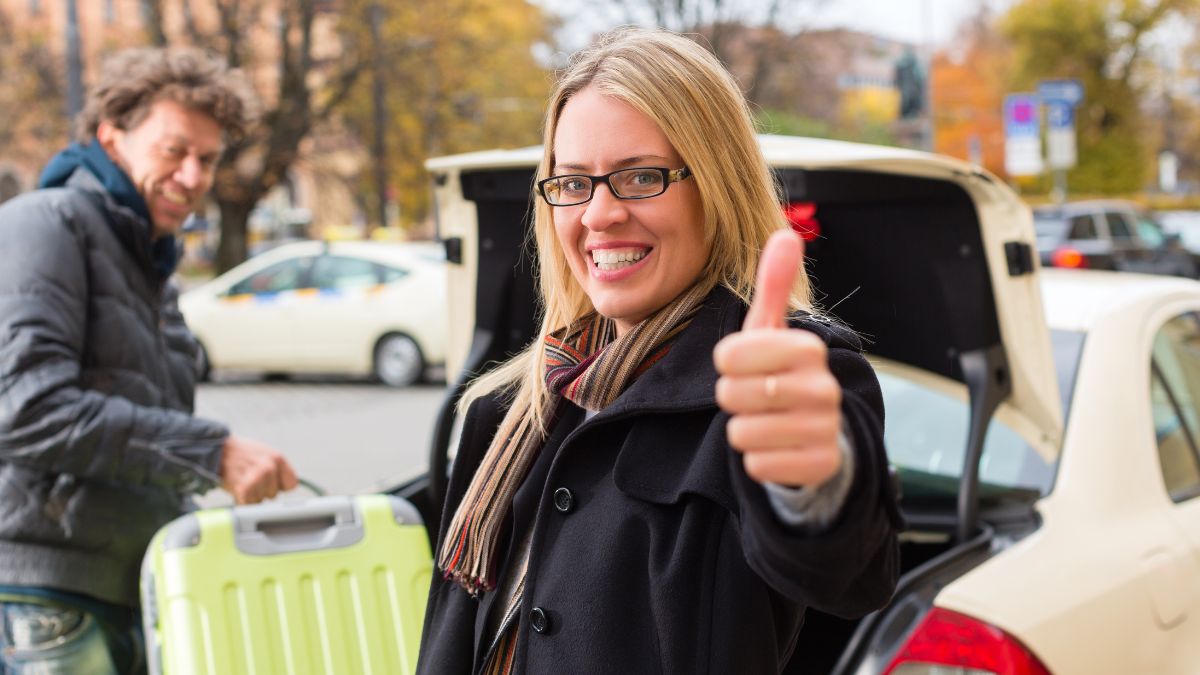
[[1039, 269, 1200, 331]]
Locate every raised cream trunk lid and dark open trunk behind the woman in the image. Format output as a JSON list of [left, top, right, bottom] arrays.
[[412, 137, 1062, 674]]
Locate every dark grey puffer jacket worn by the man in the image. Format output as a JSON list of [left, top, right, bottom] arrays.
[[0, 169, 228, 607]]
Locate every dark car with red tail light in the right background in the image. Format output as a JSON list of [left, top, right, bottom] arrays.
[[1033, 199, 1198, 279]]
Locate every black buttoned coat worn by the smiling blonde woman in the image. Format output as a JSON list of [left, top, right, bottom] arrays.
[[418, 287, 899, 675]]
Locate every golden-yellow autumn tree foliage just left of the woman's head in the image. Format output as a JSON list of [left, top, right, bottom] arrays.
[[341, 0, 553, 225]]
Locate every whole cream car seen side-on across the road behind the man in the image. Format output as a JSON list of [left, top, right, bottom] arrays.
[[180, 241, 446, 387]]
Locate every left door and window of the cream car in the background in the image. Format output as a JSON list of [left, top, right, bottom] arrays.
[[205, 256, 312, 370]]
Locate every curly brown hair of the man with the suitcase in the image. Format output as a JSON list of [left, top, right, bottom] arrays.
[[76, 47, 259, 143]]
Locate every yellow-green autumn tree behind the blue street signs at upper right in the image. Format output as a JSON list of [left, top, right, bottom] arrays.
[[1002, 0, 1195, 193]]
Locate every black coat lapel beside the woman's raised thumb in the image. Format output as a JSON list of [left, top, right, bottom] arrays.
[[593, 285, 745, 422]]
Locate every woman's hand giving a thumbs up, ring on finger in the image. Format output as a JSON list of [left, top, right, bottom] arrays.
[[713, 231, 841, 488]]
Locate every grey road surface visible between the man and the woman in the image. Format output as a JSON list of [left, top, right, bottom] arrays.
[[196, 377, 445, 506]]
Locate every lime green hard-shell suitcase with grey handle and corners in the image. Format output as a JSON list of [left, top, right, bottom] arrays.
[[142, 495, 432, 675]]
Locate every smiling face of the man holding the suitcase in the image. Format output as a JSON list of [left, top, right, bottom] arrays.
[[96, 100, 224, 238]]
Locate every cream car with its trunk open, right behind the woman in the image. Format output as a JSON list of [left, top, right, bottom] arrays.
[[384, 136, 1200, 675]]
